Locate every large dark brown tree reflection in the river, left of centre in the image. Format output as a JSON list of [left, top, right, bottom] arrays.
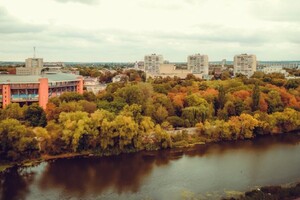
[[39, 153, 176, 196]]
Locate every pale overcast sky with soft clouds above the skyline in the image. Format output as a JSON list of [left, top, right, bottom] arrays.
[[0, 0, 300, 62]]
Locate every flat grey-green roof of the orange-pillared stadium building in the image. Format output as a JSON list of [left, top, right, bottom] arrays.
[[0, 73, 80, 84]]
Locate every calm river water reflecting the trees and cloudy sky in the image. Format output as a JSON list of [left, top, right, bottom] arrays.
[[0, 134, 300, 200]]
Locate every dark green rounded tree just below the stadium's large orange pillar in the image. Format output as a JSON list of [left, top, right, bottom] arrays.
[[25, 103, 47, 127]]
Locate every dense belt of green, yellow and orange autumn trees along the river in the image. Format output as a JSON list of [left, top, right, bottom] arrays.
[[0, 70, 300, 161]]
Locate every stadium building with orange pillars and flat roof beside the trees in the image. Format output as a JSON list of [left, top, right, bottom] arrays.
[[0, 73, 83, 109]]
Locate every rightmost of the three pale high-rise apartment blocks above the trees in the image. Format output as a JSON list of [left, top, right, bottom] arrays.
[[233, 54, 257, 77]]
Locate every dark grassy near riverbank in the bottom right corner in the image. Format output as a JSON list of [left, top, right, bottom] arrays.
[[223, 183, 300, 200]]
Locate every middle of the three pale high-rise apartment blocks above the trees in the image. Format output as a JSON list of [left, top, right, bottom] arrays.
[[187, 54, 209, 75]]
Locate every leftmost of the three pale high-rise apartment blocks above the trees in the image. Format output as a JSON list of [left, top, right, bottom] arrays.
[[144, 54, 164, 74]]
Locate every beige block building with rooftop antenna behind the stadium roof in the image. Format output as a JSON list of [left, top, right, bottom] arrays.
[[16, 58, 44, 75]]
